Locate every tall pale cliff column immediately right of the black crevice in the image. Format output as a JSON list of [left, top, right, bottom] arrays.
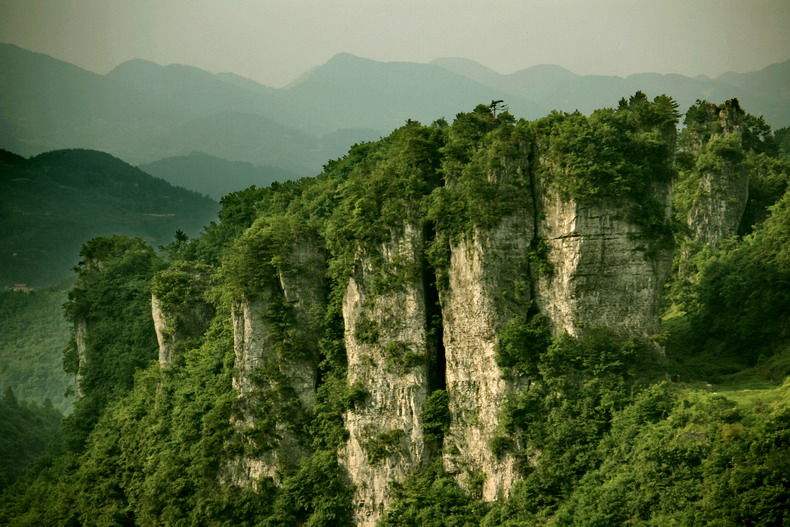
[[441, 216, 533, 501]]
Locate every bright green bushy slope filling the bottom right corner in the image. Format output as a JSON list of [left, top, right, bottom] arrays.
[[554, 383, 790, 525]]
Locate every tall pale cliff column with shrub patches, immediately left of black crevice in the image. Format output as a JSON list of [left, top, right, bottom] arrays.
[[341, 224, 429, 526]]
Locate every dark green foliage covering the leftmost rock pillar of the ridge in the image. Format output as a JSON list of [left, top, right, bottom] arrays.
[[63, 236, 161, 448]]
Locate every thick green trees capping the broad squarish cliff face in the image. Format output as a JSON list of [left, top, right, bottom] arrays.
[[535, 92, 678, 234]]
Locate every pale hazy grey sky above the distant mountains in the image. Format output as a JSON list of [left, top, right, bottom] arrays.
[[0, 0, 790, 86]]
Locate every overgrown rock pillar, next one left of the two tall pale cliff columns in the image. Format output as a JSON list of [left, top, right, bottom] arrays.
[[229, 235, 325, 485]]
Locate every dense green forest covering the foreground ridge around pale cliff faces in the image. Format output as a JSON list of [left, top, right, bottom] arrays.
[[0, 96, 790, 527]]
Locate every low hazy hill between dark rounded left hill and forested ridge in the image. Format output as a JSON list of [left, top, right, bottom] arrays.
[[139, 152, 297, 201]]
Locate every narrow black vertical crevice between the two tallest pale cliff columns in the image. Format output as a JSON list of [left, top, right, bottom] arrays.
[[420, 222, 447, 393]]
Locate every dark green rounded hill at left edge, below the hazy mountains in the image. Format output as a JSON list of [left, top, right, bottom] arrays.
[[0, 150, 217, 287]]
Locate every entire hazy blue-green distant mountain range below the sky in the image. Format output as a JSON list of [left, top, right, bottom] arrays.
[[0, 44, 790, 176]]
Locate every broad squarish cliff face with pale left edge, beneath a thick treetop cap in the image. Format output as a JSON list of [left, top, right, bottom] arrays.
[[537, 192, 671, 335]]
